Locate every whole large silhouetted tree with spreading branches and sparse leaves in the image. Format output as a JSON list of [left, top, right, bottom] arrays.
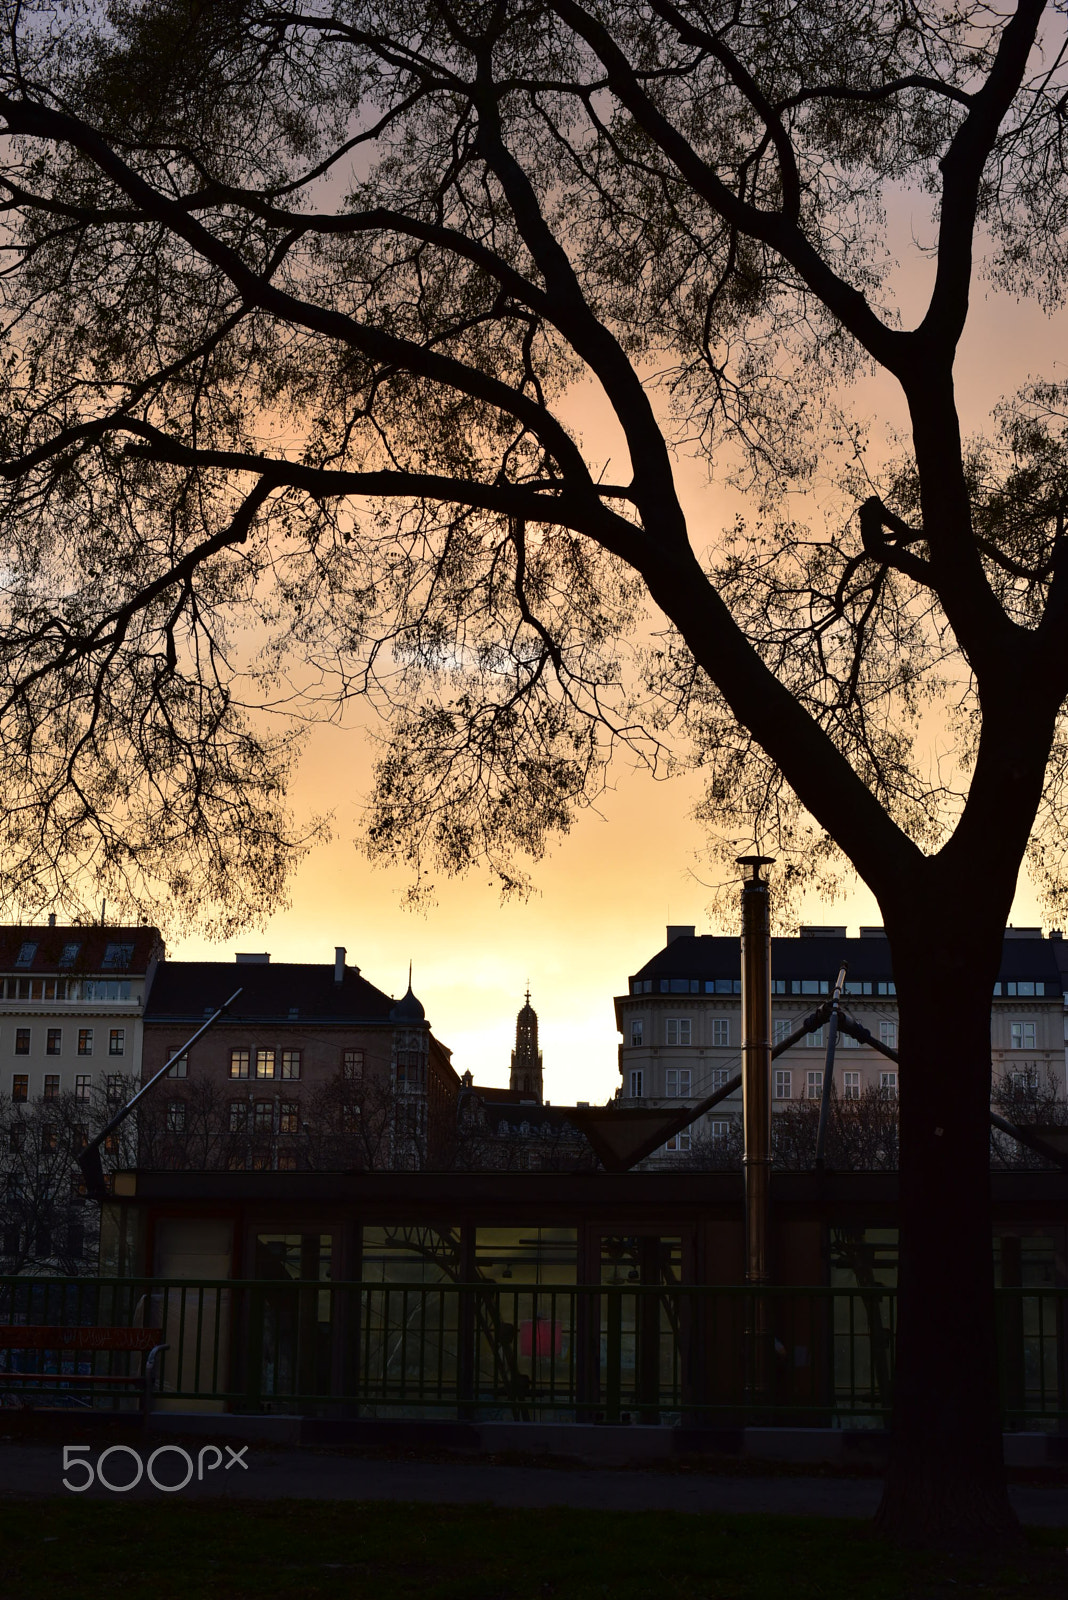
[[0, 0, 1068, 1541]]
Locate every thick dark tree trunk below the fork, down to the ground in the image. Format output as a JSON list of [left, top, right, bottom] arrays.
[[876, 928, 1022, 1549]]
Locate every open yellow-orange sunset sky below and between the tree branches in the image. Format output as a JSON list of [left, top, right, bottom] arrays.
[[169, 187, 1068, 1102]]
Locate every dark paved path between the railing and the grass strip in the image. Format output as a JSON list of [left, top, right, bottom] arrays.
[[0, 1442, 1068, 1528]]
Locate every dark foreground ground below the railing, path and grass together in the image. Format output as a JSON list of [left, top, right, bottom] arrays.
[[0, 1419, 1068, 1600]]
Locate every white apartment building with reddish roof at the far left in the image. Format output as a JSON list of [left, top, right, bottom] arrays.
[[0, 917, 163, 1106]]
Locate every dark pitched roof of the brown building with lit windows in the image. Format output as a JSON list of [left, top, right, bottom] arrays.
[[144, 962, 395, 1026]]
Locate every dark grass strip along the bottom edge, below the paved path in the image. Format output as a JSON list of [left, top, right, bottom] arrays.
[[0, 1501, 1068, 1600]]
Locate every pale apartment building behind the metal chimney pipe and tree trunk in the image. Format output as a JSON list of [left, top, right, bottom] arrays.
[[614, 926, 1068, 1155]]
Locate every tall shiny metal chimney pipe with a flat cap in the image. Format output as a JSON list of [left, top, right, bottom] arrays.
[[737, 856, 774, 1402]]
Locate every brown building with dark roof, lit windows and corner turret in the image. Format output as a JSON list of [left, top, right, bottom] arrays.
[[142, 947, 459, 1171]]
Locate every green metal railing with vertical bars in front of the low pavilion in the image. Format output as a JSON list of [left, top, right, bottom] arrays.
[[0, 1278, 1068, 1429]]
